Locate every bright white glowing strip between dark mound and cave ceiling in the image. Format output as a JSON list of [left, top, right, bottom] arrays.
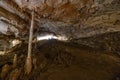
[[37, 35, 68, 41]]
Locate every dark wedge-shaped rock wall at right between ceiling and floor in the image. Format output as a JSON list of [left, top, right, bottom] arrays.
[[73, 32, 120, 55]]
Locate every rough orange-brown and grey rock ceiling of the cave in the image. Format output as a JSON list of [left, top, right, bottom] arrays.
[[0, 0, 120, 39]]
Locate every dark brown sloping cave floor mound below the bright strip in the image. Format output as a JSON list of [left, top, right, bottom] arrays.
[[0, 40, 120, 80]]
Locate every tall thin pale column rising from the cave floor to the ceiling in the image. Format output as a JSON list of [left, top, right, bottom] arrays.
[[25, 11, 34, 74]]
